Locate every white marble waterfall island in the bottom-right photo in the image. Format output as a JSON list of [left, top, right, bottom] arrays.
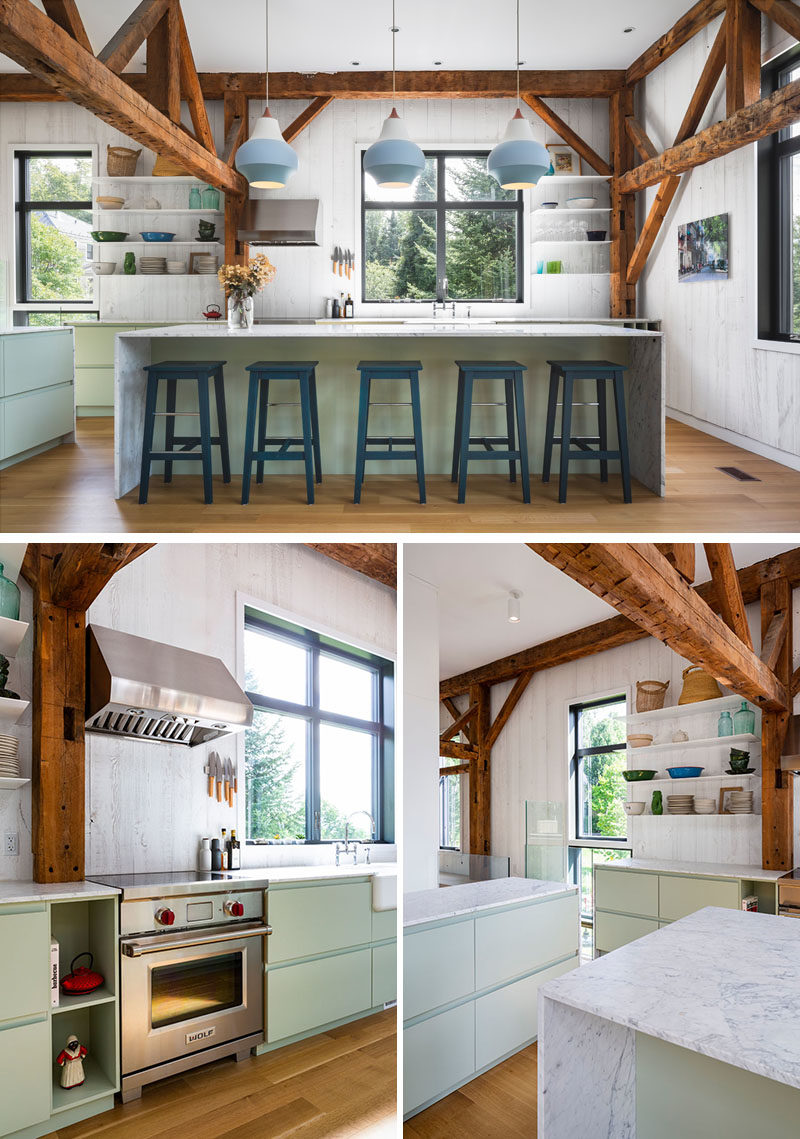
[[538, 908, 800, 1139]]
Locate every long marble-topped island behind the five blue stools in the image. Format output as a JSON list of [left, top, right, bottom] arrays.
[[114, 320, 666, 498]]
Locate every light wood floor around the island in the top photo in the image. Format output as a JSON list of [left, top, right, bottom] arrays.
[[0, 418, 800, 534]]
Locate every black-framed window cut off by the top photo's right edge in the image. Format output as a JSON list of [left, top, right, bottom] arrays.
[[758, 48, 800, 341]]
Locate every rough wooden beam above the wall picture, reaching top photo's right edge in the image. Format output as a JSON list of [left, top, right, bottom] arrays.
[[612, 80, 800, 194]]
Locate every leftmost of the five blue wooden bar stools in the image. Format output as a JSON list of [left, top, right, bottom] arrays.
[[139, 360, 230, 502]]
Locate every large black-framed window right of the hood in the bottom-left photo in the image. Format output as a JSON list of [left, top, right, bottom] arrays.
[[244, 608, 394, 842]]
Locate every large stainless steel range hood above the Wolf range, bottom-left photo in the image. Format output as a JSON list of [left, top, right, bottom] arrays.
[[85, 625, 253, 747]]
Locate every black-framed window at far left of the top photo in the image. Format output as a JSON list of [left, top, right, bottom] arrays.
[[14, 150, 93, 305]]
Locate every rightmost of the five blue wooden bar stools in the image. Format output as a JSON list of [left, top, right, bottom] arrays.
[[541, 360, 631, 502]]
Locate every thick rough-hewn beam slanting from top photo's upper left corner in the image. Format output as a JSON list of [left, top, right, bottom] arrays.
[[0, 0, 247, 197]]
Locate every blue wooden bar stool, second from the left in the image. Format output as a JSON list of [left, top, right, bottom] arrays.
[[242, 360, 323, 505]]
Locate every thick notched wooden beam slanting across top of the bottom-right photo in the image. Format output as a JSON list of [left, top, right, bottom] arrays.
[[528, 542, 789, 712]]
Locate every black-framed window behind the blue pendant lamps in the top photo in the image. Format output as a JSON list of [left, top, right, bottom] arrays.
[[361, 150, 524, 303]]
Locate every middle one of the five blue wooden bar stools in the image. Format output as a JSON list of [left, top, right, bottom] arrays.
[[353, 360, 425, 502]]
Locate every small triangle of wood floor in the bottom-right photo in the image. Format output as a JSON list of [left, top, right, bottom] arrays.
[[403, 1044, 537, 1139]]
